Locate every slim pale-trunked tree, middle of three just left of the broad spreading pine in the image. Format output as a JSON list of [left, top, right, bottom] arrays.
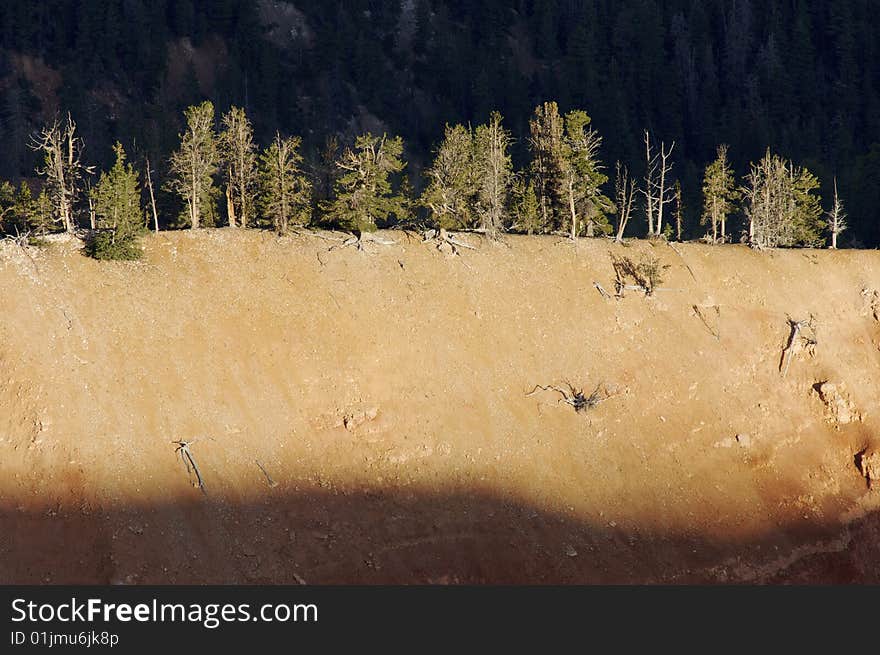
[[219, 107, 258, 227]]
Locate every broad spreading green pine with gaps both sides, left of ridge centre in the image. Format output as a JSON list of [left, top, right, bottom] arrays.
[[324, 133, 406, 237]]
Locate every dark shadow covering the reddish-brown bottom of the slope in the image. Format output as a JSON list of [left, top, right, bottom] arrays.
[[0, 489, 880, 584]]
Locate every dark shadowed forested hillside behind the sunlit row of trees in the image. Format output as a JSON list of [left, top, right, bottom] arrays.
[[0, 0, 880, 246]]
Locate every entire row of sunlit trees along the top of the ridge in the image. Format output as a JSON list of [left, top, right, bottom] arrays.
[[0, 100, 847, 259]]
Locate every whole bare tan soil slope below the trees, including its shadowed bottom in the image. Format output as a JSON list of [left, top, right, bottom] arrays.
[[0, 229, 880, 583]]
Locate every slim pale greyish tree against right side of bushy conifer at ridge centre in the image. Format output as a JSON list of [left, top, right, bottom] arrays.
[[474, 111, 513, 237]]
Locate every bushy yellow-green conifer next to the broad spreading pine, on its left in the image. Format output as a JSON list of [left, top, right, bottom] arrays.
[[260, 132, 312, 235]]
